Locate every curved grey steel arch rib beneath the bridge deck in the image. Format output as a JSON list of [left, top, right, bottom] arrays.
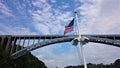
[[11, 36, 120, 59]]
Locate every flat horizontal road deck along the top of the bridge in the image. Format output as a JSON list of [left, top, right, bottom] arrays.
[[0, 34, 120, 40]]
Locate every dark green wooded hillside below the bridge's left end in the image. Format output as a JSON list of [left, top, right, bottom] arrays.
[[0, 46, 47, 68]]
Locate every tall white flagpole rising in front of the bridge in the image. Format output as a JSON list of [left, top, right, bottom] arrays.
[[75, 12, 87, 68]]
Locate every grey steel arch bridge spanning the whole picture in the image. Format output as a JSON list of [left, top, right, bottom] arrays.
[[0, 35, 120, 59]]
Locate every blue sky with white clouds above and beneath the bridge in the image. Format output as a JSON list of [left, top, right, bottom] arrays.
[[0, 0, 120, 68]]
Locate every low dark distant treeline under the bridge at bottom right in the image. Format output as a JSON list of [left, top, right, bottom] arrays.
[[65, 59, 120, 68]]
